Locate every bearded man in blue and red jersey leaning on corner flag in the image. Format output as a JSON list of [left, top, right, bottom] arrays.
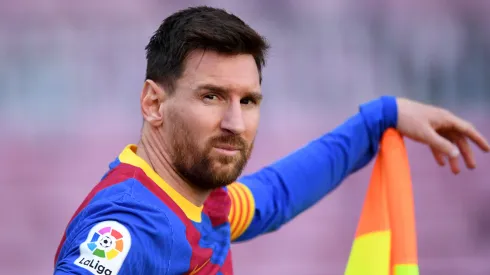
[[55, 4, 490, 275]]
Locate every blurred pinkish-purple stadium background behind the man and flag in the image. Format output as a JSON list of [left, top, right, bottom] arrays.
[[0, 0, 490, 275]]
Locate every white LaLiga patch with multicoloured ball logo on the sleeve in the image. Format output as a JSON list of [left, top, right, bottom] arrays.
[[75, 221, 131, 275]]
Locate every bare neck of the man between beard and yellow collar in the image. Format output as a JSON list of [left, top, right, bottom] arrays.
[[136, 133, 211, 206]]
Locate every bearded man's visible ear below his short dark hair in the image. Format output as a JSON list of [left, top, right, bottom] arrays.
[[140, 79, 167, 126]]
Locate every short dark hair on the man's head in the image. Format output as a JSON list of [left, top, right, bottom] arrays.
[[145, 6, 269, 90]]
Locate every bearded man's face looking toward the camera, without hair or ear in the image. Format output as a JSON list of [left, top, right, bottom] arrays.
[[161, 51, 261, 190]]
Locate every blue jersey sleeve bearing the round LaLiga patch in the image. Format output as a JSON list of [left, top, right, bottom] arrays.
[[54, 195, 172, 275]]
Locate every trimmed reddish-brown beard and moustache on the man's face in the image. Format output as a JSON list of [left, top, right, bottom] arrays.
[[167, 111, 253, 190]]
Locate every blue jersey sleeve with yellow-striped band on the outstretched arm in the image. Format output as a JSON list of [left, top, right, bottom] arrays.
[[228, 97, 398, 242]]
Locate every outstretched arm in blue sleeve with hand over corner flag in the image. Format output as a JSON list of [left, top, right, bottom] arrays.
[[228, 97, 490, 241]]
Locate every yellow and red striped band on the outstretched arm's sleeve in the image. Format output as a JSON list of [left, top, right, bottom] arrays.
[[228, 182, 255, 241]]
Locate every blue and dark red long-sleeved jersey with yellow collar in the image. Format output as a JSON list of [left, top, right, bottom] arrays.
[[54, 97, 397, 275]]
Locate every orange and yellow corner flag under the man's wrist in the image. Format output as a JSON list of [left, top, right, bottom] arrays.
[[345, 129, 419, 275]]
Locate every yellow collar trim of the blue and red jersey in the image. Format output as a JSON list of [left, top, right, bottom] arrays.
[[119, 144, 203, 222]]
